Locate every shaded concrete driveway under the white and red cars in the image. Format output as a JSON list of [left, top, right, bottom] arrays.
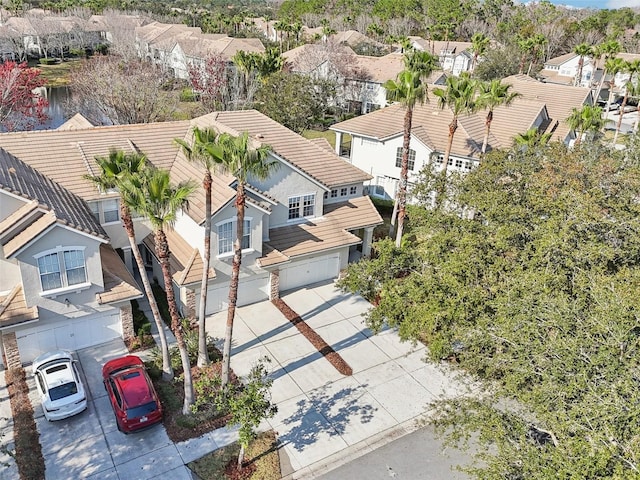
[[27, 340, 192, 480]]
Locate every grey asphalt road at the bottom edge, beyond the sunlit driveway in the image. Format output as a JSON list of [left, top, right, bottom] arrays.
[[318, 426, 471, 480]]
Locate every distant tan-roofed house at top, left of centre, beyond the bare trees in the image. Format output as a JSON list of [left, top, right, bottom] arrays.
[[136, 22, 265, 79]]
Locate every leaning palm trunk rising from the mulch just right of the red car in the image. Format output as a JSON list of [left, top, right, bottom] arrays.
[[155, 229, 193, 415]]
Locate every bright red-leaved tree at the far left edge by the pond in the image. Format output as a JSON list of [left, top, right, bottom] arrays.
[[0, 61, 49, 132]]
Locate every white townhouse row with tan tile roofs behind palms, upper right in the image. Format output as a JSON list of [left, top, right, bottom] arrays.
[[330, 75, 593, 199]]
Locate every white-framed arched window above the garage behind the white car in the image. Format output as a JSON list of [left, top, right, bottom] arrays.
[[33, 245, 91, 297]]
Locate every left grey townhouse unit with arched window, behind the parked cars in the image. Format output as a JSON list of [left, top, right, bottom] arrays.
[[0, 149, 142, 368]]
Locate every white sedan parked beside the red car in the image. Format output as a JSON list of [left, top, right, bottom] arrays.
[[32, 350, 87, 421]]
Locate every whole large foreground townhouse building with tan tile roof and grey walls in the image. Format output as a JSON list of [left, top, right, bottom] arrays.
[[0, 110, 382, 370]]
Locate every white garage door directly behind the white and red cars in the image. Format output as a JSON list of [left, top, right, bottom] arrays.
[[16, 314, 122, 363]]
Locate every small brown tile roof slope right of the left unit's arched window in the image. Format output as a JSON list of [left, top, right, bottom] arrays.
[[96, 245, 142, 305]]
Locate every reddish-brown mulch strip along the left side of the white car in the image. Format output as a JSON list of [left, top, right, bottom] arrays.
[[6, 368, 45, 480]]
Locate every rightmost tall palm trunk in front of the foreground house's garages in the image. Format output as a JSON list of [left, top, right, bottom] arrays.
[[222, 182, 245, 385]]
